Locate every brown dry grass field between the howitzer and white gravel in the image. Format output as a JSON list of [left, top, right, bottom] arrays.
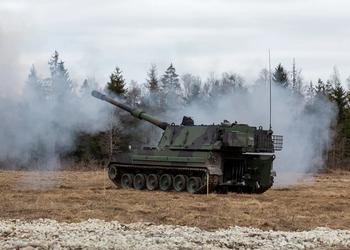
[[0, 171, 350, 231]]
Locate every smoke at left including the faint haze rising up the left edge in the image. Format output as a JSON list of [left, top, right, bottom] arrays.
[[0, 27, 108, 169]]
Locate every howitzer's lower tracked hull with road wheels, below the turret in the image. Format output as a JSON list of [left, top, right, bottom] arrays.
[[108, 126, 275, 193]]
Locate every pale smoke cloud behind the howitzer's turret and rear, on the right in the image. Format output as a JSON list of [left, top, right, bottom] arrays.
[[172, 85, 337, 185]]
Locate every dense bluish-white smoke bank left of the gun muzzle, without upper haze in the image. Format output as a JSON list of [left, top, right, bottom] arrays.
[[0, 85, 108, 169]]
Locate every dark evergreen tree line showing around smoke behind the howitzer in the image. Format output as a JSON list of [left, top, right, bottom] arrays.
[[27, 52, 350, 166]]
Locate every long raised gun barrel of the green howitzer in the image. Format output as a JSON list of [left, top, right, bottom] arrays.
[[91, 90, 169, 130]]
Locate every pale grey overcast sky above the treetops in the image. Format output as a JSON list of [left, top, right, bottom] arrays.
[[0, 0, 350, 89]]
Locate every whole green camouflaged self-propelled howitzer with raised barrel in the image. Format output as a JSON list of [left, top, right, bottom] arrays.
[[92, 91, 283, 193]]
